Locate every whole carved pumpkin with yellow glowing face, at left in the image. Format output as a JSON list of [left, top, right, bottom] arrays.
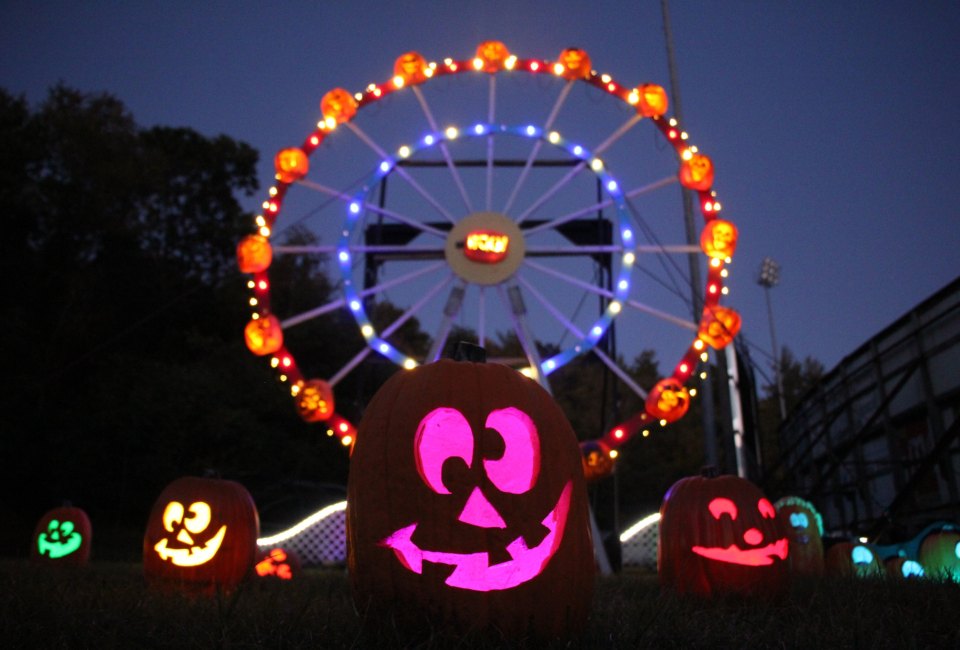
[[143, 476, 260, 594]]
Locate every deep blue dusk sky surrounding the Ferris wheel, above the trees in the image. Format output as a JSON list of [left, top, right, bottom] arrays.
[[0, 0, 960, 388]]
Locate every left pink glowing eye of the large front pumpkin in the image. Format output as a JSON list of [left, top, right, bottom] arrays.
[[413, 407, 474, 494]]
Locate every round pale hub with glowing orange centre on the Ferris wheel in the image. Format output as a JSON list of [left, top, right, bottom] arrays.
[[444, 212, 526, 285]]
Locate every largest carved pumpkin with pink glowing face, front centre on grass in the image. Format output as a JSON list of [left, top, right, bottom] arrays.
[[347, 360, 594, 638]]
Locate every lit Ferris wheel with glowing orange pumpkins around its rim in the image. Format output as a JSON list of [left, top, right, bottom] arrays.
[[237, 41, 740, 473]]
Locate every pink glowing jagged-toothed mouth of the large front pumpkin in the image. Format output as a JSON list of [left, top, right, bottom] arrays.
[[380, 481, 568, 591]]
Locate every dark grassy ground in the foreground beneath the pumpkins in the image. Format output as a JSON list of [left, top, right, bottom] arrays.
[[0, 560, 960, 649]]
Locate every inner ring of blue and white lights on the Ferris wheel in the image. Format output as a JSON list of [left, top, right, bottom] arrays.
[[336, 124, 635, 376]]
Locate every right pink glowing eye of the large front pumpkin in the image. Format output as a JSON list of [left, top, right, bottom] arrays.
[[483, 407, 540, 494]]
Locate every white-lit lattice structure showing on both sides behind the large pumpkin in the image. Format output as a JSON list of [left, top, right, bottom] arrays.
[[257, 501, 660, 568]]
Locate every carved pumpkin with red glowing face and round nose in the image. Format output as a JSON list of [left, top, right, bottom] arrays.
[[657, 468, 788, 596]]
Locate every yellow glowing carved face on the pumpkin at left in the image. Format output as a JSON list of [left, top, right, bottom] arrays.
[[153, 501, 227, 566]]
